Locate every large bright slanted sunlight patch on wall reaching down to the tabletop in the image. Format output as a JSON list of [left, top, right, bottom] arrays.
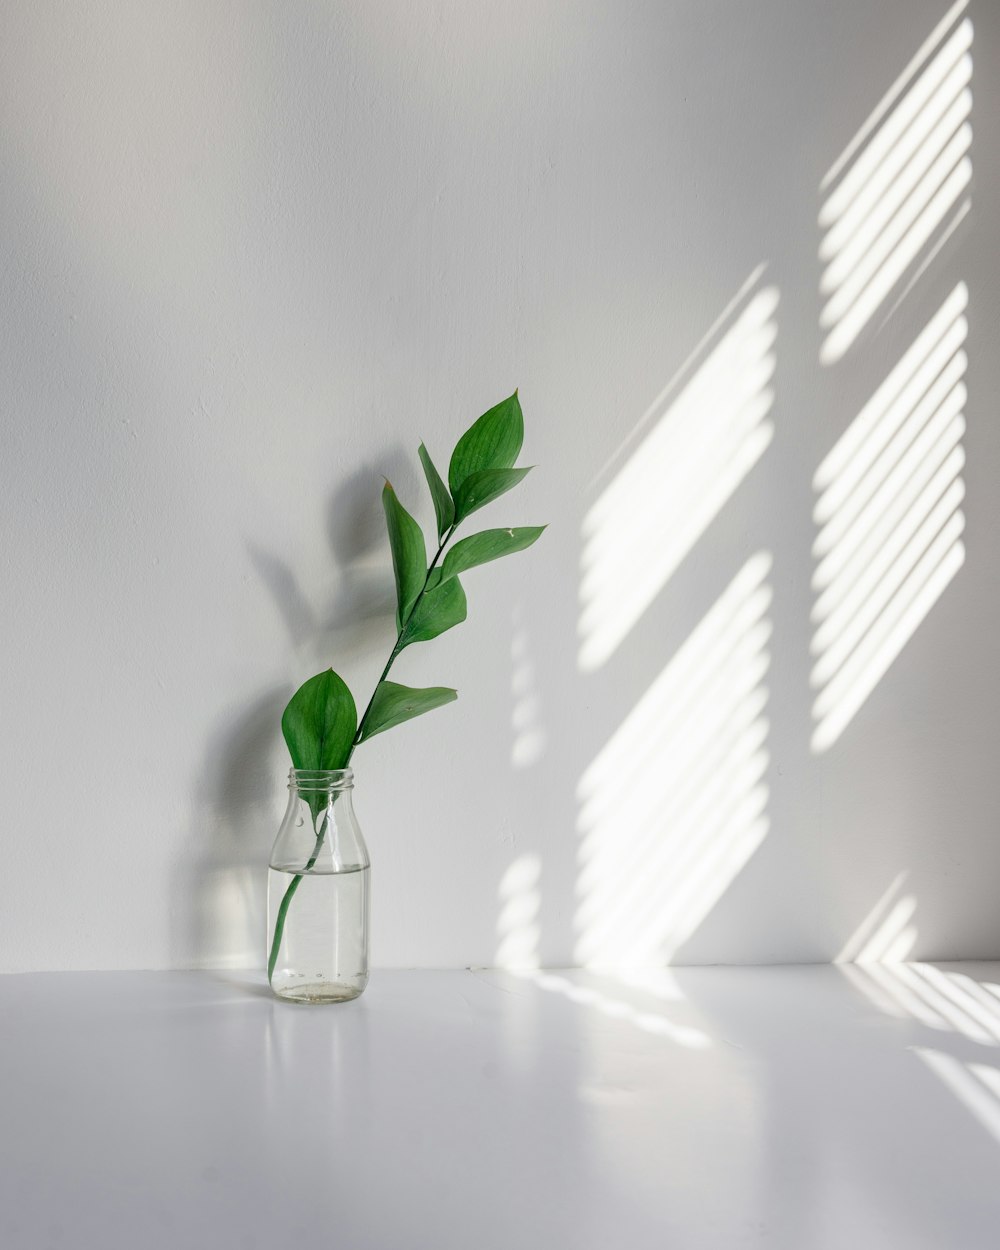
[[575, 553, 771, 968]]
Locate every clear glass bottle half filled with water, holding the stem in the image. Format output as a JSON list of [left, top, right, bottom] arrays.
[[268, 769, 371, 1003]]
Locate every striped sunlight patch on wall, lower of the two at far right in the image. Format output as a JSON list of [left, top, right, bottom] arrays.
[[811, 283, 969, 753]]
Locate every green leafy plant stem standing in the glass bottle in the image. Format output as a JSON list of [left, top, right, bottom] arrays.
[[268, 391, 545, 980]]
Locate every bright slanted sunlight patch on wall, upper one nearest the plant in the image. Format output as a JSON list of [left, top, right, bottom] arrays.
[[579, 266, 778, 671]]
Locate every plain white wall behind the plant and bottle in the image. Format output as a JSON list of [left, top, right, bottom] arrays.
[[0, 0, 1000, 970]]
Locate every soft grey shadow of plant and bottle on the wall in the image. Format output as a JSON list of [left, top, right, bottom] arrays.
[[173, 448, 409, 968]]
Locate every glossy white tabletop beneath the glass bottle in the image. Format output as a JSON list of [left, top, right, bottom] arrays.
[[0, 964, 1000, 1250]]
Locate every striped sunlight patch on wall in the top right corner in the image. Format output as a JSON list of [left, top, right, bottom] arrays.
[[819, 3, 973, 365]]
